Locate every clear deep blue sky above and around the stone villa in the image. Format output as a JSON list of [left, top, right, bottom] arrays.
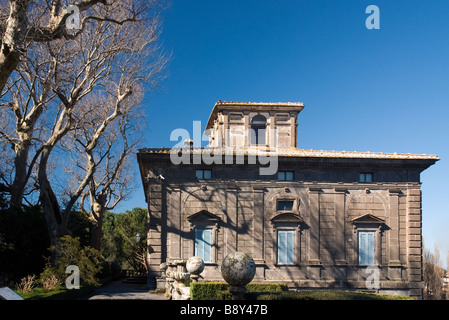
[[116, 0, 449, 264]]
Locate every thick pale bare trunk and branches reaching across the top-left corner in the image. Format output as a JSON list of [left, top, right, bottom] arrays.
[[0, 0, 157, 92]]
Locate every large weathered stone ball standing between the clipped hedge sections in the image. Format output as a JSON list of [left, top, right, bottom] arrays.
[[221, 252, 256, 287]]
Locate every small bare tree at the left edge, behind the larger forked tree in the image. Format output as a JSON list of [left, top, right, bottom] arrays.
[[0, 32, 56, 207]]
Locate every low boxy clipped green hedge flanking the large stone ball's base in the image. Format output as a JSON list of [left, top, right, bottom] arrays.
[[190, 281, 288, 300]]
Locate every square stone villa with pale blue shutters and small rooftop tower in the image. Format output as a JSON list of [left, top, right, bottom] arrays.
[[137, 101, 438, 297]]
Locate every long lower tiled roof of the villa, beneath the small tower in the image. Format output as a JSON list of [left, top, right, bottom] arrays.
[[139, 148, 439, 161]]
